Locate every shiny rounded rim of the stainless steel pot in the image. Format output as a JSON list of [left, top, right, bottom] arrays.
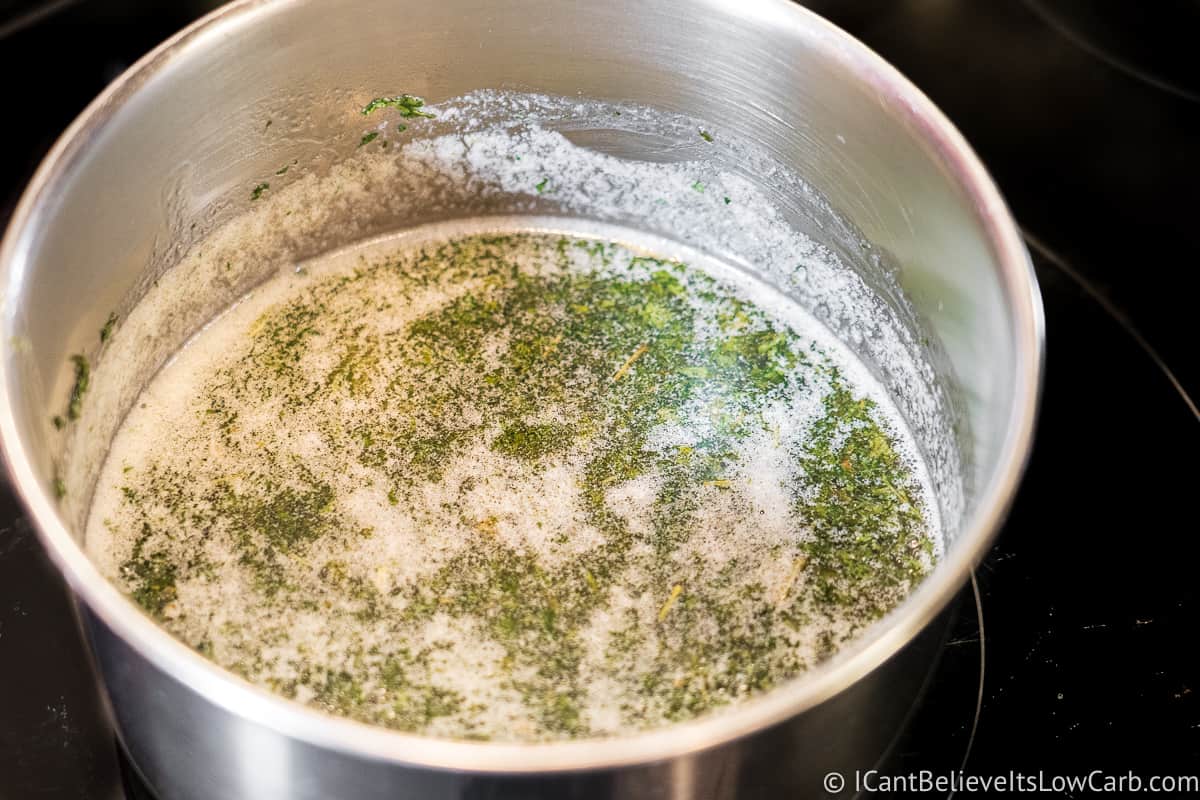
[[0, 0, 1045, 774]]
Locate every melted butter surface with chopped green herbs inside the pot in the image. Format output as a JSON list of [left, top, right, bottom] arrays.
[[86, 220, 937, 741]]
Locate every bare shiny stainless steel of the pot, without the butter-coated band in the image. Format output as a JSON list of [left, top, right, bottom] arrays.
[[0, 0, 1043, 800]]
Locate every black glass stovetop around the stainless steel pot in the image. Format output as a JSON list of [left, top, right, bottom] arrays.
[[0, 0, 1200, 800]]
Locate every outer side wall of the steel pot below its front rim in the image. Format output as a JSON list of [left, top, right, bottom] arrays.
[[89, 606, 948, 800]]
